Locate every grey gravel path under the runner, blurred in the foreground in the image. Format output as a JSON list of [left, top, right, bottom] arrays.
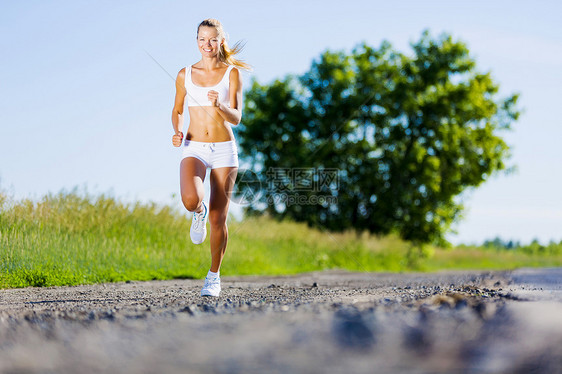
[[0, 269, 562, 374]]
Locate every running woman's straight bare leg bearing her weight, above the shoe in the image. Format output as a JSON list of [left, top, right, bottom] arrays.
[[209, 167, 238, 273]]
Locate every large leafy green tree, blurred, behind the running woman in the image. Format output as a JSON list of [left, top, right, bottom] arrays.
[[235, 31, 519, 244]]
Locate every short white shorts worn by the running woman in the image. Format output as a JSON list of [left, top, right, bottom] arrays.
[[182, 139, 238, 169]]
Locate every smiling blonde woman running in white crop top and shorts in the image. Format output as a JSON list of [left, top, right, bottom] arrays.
[[172, 19, 250, 297]]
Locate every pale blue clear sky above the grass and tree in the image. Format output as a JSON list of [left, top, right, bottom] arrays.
[[0, 1, 562, 243]]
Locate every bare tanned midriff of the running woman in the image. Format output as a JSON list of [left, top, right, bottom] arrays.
[[185, 106, 234, 143]]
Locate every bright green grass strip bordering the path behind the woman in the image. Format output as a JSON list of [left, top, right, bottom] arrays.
[[0, 191, 562, 288]]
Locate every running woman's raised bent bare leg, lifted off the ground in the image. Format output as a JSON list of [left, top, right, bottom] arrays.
[[180, 157, 207, 213]]
